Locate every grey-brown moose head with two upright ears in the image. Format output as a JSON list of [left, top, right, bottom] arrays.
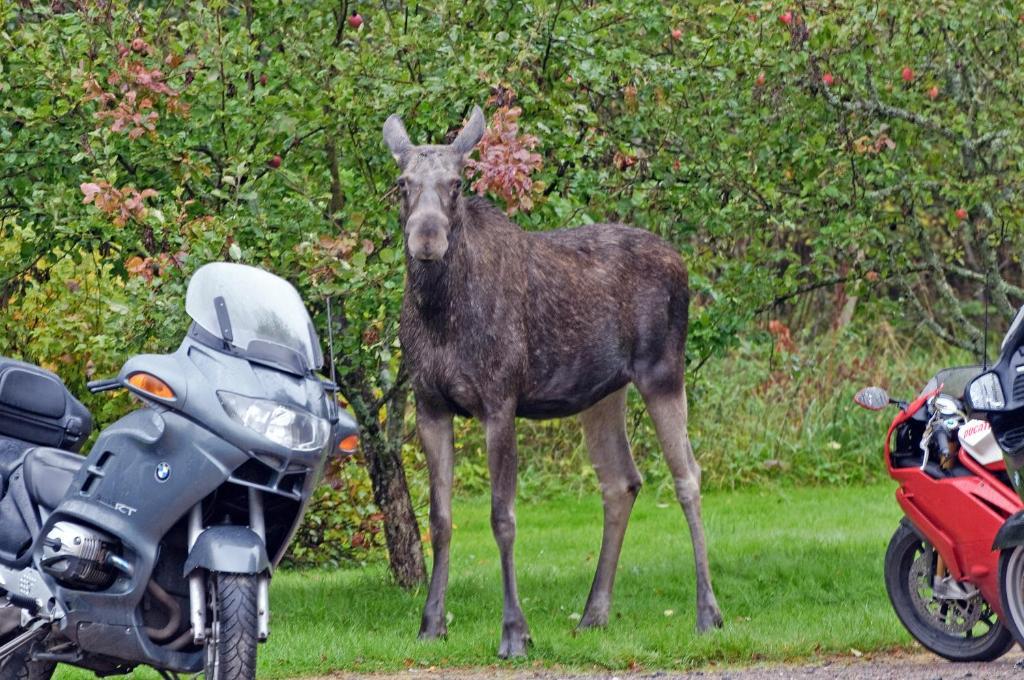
[[384, 107, 484, 262]]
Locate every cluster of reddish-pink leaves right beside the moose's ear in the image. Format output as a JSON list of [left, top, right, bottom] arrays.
[[466, 107, 543, 214]]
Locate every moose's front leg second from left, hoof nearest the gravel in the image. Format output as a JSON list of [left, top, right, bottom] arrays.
[[484, 408, 529, 658]]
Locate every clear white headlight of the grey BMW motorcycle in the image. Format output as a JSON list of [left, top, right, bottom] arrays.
[[217, 392, 331, 451]]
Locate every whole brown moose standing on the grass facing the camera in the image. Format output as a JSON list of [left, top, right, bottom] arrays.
[[383, 107, 722, 658]]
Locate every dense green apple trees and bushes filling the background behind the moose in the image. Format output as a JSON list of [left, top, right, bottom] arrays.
[[0, 0, 1024, 561]]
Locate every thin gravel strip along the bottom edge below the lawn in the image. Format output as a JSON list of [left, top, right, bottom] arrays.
[[317, 651, 1024, 680]]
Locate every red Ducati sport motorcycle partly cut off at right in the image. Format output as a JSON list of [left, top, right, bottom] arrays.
[[854, 367, 1024, 662]]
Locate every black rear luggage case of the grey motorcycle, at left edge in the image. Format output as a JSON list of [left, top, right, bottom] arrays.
[[0, 356, 92, 451]]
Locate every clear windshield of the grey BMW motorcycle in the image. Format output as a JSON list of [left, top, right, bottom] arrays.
[[185, 262, 324, 373]]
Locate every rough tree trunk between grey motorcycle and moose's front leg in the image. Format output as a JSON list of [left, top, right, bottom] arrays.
[[362, 430, 427, 588]]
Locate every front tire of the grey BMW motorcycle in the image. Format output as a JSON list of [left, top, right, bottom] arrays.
[[206, 572, 258, 680]]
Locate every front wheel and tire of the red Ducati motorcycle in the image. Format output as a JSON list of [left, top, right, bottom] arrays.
[[885, 519, 1014, 662]]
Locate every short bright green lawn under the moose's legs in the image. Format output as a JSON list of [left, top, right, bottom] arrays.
[[60, 481, 910, 678]]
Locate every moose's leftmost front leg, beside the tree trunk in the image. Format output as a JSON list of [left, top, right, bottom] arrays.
[[416, 403, 455, 640]]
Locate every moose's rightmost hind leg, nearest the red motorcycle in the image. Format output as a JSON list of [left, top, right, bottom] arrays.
[[641, 386, 722, 633]]
